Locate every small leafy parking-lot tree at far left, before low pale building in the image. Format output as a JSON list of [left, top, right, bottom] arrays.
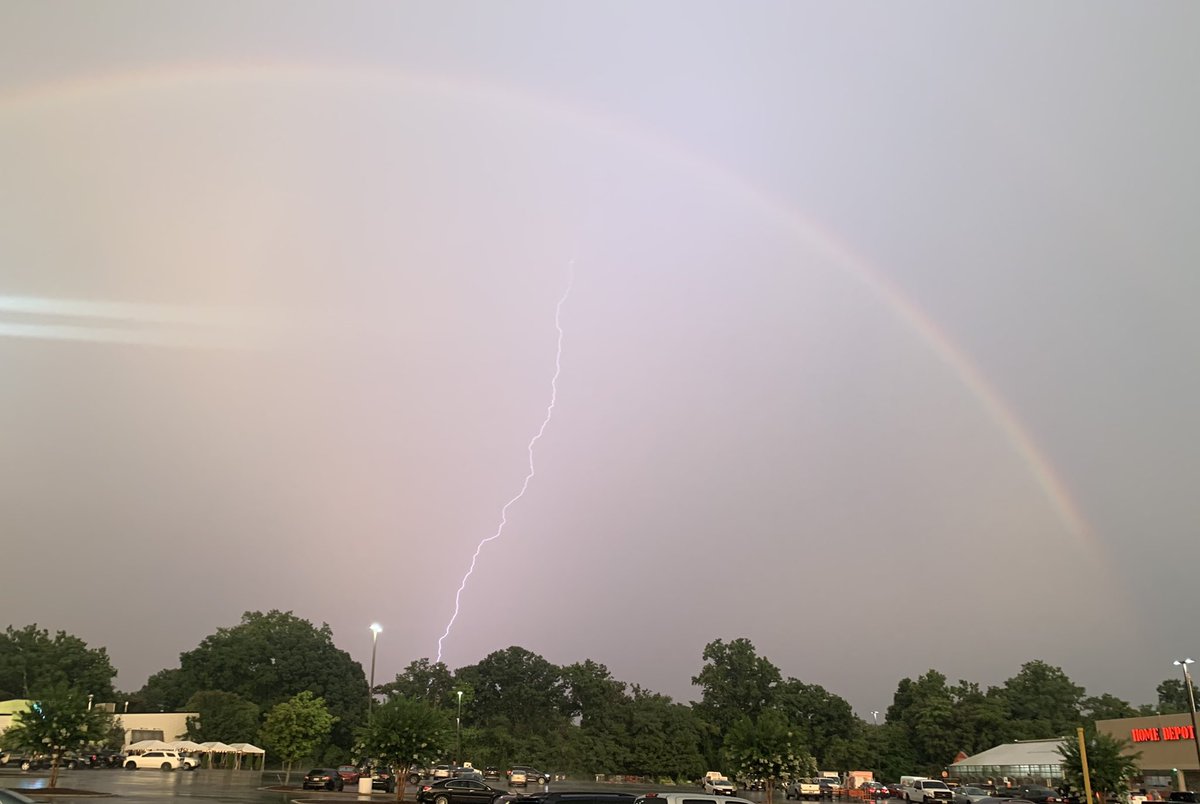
[[0, 683, 113, 787]]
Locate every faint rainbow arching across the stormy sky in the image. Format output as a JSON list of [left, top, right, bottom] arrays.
[[0, 62, 1088, 544]]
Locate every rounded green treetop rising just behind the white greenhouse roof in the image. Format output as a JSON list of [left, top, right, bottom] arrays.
[[1003, 660, 1084, 739]]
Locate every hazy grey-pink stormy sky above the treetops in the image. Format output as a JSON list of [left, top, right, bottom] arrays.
[[0, 0, 1200, 716]]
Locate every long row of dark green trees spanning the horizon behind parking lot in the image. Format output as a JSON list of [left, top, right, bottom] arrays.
[[0, 611, 1188, 780]]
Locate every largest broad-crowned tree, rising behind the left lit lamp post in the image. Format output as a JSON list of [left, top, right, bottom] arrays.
[[172, 611, 368, 750]]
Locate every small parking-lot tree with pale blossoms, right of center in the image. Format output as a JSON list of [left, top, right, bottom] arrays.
[[724, 710, 817, 804]]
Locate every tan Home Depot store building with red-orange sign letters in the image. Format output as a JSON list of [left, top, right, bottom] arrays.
[[1096, 713, 1200, 790]]
